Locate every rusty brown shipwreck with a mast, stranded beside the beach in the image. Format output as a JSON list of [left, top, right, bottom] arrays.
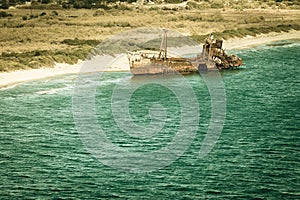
[[128, 32, 243, 75]]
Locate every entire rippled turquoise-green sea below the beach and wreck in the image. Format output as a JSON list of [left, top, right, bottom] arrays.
[[0, 40, 300, 199]]
